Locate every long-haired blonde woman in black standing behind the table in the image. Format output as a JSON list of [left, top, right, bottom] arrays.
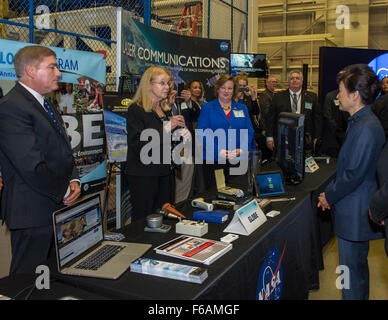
[[126, 67, 185, 221]]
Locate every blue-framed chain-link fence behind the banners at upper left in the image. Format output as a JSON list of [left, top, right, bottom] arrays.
[[0, 0, 248, 90]]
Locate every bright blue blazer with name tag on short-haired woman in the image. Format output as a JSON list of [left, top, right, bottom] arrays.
[[196, 99, 256, 162]]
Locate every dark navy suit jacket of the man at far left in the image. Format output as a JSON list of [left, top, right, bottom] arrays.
[[0, 83, 78, 229]]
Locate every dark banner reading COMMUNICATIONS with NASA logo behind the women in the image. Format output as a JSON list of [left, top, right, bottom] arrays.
[[120, 12, 231, 100]]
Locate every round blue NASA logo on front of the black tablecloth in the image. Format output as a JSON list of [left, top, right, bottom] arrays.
[[256, 247, 285, 300]]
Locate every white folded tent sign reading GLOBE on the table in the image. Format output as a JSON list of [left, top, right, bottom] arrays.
[[224, 199, 267, 236]]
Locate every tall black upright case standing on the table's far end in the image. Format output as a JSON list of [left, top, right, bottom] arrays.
[[276, 112, 305, 184]]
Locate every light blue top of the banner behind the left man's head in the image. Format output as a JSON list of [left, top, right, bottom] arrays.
[[0, 40, 106, 84]]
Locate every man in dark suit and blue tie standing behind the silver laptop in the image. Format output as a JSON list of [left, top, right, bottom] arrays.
[[0, 46, 80, 274]]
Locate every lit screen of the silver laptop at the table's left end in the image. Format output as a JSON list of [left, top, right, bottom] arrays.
[[54, 195, 104, 267]]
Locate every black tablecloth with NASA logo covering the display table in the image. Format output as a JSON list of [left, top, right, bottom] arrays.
[[51, 162, 336, 300]]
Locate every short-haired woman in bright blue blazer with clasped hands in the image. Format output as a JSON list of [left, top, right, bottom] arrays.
[[196, 75, 256, 188]]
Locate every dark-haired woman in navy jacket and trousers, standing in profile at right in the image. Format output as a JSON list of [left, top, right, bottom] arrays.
[[318, 64, 385, 300]]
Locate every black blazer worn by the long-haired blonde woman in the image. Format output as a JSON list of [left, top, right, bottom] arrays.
[[126, 104, 172, 176]]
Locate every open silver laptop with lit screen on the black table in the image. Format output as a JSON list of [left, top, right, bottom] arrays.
[[53, 195, 151, 279]]
